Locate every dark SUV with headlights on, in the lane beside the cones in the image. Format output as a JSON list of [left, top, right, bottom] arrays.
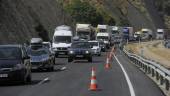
[[68, 41, 92, 62]]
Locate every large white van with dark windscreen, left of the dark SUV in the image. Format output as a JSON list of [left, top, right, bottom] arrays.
[[52, 25, 73, 57]]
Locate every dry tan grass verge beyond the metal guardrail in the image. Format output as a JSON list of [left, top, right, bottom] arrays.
[[126, 41, 170, 69]]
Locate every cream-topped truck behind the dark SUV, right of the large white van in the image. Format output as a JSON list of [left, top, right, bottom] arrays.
[[76, 24, 95, 40]]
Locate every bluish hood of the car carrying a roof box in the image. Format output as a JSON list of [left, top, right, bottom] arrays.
[[30, 55, 49, 62]]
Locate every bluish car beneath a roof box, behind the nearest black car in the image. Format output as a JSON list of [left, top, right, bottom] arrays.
[[30, 48, 55, 71]]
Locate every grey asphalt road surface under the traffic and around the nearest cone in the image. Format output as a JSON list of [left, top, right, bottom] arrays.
[[0, 50, 164, 96]]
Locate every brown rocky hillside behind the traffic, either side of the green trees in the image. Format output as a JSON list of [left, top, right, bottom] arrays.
[[0, 0, 170, 43]]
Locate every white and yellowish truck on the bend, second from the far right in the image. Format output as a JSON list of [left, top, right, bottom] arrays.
[[141, 28, 153, 40]]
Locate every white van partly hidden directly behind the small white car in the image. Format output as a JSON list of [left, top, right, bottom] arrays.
[[96, 32, 111, 48]]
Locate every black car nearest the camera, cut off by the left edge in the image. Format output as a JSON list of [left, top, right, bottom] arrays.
[[0, 45, 31, 83]]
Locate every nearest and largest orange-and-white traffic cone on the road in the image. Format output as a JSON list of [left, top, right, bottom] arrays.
[[89, 67, 98, 91]]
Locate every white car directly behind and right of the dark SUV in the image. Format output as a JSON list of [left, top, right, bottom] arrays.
[[88, 40, 101, 56]]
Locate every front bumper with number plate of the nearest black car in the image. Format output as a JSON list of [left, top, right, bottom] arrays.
[[0, 69, 26, 81]]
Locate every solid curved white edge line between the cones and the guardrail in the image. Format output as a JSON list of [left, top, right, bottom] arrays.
[[114, 55, 136, 96]]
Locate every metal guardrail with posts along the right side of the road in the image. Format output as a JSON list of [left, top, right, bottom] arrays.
[[123, 47, 170, 91]]
